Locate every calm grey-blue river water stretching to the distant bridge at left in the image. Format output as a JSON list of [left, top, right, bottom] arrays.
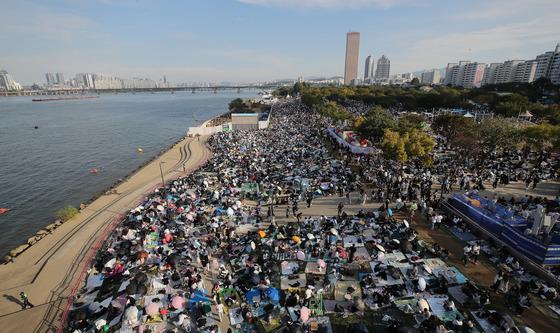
[[0, 91, 257, 256]]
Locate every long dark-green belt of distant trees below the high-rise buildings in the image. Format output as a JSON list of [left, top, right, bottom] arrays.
[[290, 79, 560, 125]]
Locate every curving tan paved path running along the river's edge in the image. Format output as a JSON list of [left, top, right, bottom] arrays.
[[0, 137, 211, 332]]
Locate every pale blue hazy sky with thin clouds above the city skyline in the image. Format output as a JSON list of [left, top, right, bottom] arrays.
[[0, 0, 560, 84]]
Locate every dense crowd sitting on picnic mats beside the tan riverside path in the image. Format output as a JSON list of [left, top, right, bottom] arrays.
[[69, 101, 557, 333]]
